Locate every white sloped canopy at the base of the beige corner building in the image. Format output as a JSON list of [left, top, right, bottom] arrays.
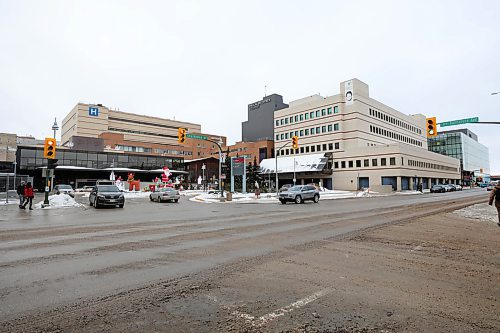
[[260, 154, 328, 174]]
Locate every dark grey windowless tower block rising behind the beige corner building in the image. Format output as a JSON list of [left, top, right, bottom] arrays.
[[241, 94, 288, 142]]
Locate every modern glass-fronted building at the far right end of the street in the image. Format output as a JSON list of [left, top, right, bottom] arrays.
[[428, 129, 490, 185]]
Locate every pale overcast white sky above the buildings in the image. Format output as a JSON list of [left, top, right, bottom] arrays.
[[0, 0, 500, 174]]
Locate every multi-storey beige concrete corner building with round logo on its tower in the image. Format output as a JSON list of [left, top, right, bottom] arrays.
[[268, 79, 460, 190]]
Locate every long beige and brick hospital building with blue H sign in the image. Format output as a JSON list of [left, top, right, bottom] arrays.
[[61, 103, 226, 159]]
